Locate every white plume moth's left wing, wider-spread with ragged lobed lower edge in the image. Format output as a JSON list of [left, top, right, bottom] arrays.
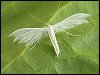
[[9, 28, 47, 46]]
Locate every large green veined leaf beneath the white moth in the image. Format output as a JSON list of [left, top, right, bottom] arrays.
[[1, 1, 99, 74]]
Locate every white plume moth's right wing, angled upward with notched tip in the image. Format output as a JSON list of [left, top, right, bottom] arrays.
[[52, 13, 90, 32]]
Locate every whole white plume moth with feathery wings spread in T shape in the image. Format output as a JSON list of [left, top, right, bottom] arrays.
[[9, 3, 90, 57]]
